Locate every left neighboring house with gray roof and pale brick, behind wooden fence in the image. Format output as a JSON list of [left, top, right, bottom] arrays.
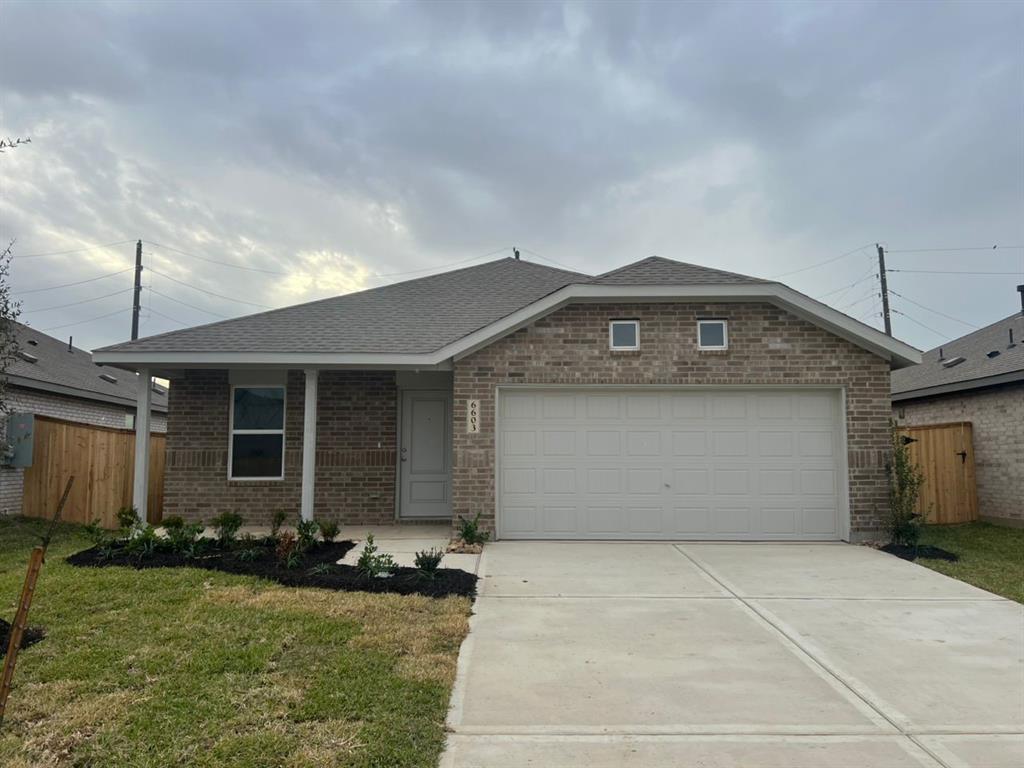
[[0, 323, 167, 514]]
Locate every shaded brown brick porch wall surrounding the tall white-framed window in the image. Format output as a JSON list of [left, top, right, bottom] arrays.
[[164, 371, 397, 524]]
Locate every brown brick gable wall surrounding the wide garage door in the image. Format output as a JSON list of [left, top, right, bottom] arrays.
[[453, 303, 890, 539]]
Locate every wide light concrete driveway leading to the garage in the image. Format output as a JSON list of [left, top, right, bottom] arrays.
[[441, 542, 1024, 768]]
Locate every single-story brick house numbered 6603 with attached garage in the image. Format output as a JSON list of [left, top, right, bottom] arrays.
[[95, 257, 921, 540]]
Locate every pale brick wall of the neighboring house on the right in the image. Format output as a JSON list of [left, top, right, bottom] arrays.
[[893, 383, 1024, 525]]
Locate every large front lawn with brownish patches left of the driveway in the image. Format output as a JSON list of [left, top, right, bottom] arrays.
[[0, 518, 470, 768]]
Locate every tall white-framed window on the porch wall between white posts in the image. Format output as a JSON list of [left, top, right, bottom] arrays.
[[228, 385, 285, 480]]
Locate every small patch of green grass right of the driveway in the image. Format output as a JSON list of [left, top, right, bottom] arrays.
[[918, 522, 1024, 603]]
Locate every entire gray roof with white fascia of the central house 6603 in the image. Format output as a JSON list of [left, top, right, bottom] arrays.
[[95, 257, 920, 371]]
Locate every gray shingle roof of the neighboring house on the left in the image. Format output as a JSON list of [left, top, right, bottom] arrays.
[[6, 323, 167, 411]]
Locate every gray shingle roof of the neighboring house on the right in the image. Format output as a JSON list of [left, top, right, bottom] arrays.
[[892, 312, 1024, 399]]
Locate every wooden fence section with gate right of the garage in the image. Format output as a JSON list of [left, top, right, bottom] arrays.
[[900, 421, 978, 523]]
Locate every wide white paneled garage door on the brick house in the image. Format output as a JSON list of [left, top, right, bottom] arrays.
[[498, 389, 846, 540]]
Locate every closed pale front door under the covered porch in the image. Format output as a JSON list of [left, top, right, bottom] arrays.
[[398, 389, 452, 517]]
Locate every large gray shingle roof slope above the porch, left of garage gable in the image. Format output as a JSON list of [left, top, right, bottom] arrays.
[[97, 258, 590, 354]]
